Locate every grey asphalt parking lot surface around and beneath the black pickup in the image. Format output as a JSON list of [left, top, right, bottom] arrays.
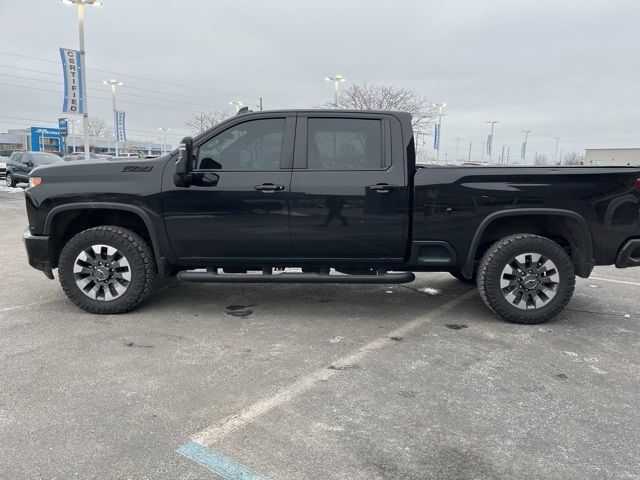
[[0, 189, 640, 480]]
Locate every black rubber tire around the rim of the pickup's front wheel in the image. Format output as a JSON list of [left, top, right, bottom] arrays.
[[58, 225, 156, 315]]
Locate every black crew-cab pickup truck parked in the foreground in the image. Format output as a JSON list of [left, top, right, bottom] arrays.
[[24, 110, 640, 323]]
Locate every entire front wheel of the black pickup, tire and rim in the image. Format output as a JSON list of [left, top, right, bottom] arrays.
[[58, 226, 155, 314]]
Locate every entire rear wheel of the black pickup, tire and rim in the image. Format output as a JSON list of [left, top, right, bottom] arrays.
[[478, 234, 575, 324]]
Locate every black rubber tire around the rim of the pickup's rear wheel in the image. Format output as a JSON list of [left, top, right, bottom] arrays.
[[478, 234, 576, 324]]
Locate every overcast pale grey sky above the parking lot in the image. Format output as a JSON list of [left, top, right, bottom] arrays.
[[0, 0, 640, 158]]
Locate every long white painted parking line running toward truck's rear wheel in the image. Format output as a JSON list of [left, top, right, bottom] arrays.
[[191, 289, 477, 447]]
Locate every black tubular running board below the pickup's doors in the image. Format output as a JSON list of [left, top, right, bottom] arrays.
[[178, 271, 416, 284]]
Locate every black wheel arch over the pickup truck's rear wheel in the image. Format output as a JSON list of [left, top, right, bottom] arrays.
[[462, 208, 594, 278]]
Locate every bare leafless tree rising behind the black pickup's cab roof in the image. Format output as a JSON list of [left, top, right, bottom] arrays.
[[322, 83, 438, 135]]
